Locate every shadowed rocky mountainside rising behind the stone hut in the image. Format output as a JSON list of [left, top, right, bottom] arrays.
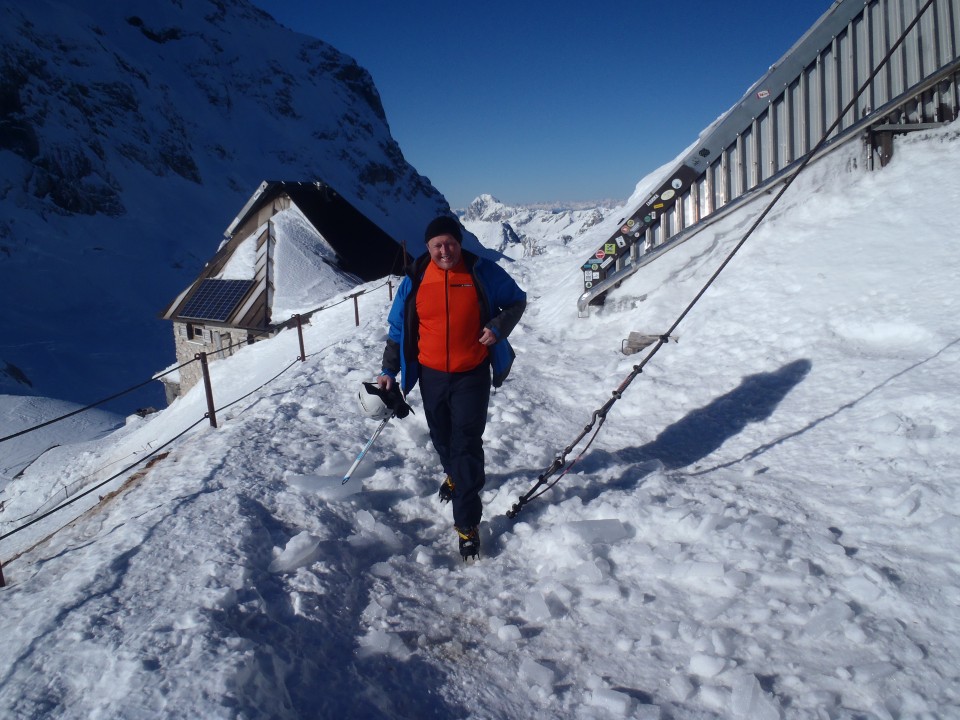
[[0, 0, 448, 411]]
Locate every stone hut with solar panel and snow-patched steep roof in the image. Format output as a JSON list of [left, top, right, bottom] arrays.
[[160, 181, 405, 403]]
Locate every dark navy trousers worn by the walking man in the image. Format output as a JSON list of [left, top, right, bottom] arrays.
[[420, 362, 490, 529]]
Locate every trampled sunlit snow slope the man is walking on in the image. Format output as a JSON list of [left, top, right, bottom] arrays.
[[0, 123, 960, 720]]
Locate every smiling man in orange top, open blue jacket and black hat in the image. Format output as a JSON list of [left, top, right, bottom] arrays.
[[377, 216, 527, 560]]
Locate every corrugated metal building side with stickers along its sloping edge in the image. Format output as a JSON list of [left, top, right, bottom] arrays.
[[578, 0, 960, 312]]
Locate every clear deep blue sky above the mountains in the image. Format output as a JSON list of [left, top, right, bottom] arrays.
[[252, 0, 832, 208]]
